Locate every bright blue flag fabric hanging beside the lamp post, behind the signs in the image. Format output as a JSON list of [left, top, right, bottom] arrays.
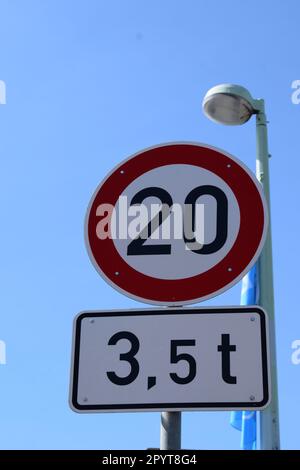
[[230, 265, 259, 450]]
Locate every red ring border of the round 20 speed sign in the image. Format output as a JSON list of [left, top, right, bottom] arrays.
[[85, 143, 268, 305]]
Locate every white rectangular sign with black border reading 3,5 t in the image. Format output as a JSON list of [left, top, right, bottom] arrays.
[[70, 306, 270, 412]]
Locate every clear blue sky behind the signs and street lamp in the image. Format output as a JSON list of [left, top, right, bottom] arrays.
[[0, 0, 300, 449]]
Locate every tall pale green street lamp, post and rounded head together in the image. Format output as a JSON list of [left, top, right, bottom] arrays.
[[203, 84, 280, 450]]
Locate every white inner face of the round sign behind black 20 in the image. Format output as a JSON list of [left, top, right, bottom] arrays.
[[114, 165, 240, 280]]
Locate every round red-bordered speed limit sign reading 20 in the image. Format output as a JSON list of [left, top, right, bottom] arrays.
[[85, 143, 267, 305]]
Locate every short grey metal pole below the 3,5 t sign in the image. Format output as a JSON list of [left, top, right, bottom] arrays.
[[160, 411, 181, 450]]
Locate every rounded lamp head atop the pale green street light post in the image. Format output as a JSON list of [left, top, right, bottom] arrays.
[[202, 83, 256, 126]]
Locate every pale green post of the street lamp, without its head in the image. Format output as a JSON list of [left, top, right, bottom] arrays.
[[255, 100, 280, 450]]
